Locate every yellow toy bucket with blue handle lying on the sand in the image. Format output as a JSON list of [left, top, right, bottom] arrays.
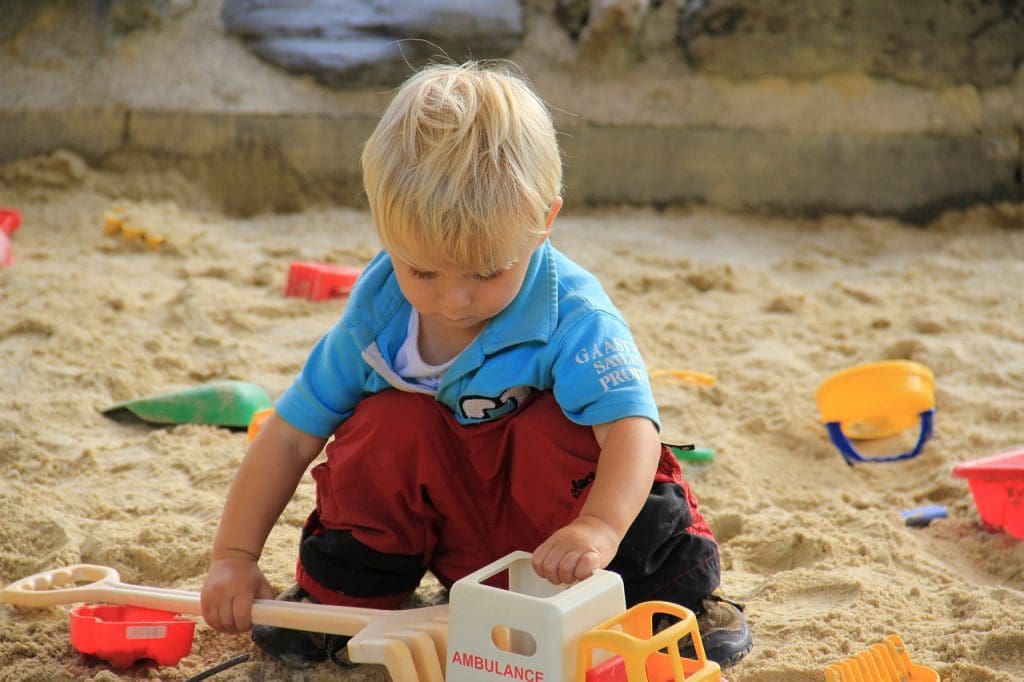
[[816, 360, 935, 465]]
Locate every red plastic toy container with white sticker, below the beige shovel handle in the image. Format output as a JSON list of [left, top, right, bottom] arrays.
[[71, 604, 196, 668]]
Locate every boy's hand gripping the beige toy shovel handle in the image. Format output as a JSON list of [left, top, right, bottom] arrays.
[[200, 550, 275, 633]]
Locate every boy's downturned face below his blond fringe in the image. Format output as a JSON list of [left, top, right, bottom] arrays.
[[393, 237, 537, 334]]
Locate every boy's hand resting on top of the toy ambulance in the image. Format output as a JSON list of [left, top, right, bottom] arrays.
[[532, 515, 622, 585]]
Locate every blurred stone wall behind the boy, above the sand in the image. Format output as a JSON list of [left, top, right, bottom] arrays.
[[0, 0, 1024, 222]]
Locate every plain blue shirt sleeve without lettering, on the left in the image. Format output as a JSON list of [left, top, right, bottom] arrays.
[[274, 317, 368, 438]]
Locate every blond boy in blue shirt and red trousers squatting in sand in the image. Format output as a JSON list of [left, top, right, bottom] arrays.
[[202, 62, 752, 665]]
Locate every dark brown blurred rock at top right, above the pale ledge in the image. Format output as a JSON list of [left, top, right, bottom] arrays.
[[678, 0, 1024, 87]]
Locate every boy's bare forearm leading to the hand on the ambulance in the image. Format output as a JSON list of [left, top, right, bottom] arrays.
[[580, 417, 662, 540]]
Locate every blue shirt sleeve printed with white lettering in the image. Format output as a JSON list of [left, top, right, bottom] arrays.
[[554, 311, 660, 429]]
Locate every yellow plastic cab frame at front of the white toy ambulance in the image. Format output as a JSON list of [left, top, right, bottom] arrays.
[[575, 601, 722, 682]]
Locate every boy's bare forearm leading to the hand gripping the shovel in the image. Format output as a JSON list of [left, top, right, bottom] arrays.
[[212, 415, 325, 560]]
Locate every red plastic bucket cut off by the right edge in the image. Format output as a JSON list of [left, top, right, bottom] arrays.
[[953, 449, 1024, 539]]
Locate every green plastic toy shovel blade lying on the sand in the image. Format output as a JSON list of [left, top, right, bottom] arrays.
[[102, 381, 272, 428]]
